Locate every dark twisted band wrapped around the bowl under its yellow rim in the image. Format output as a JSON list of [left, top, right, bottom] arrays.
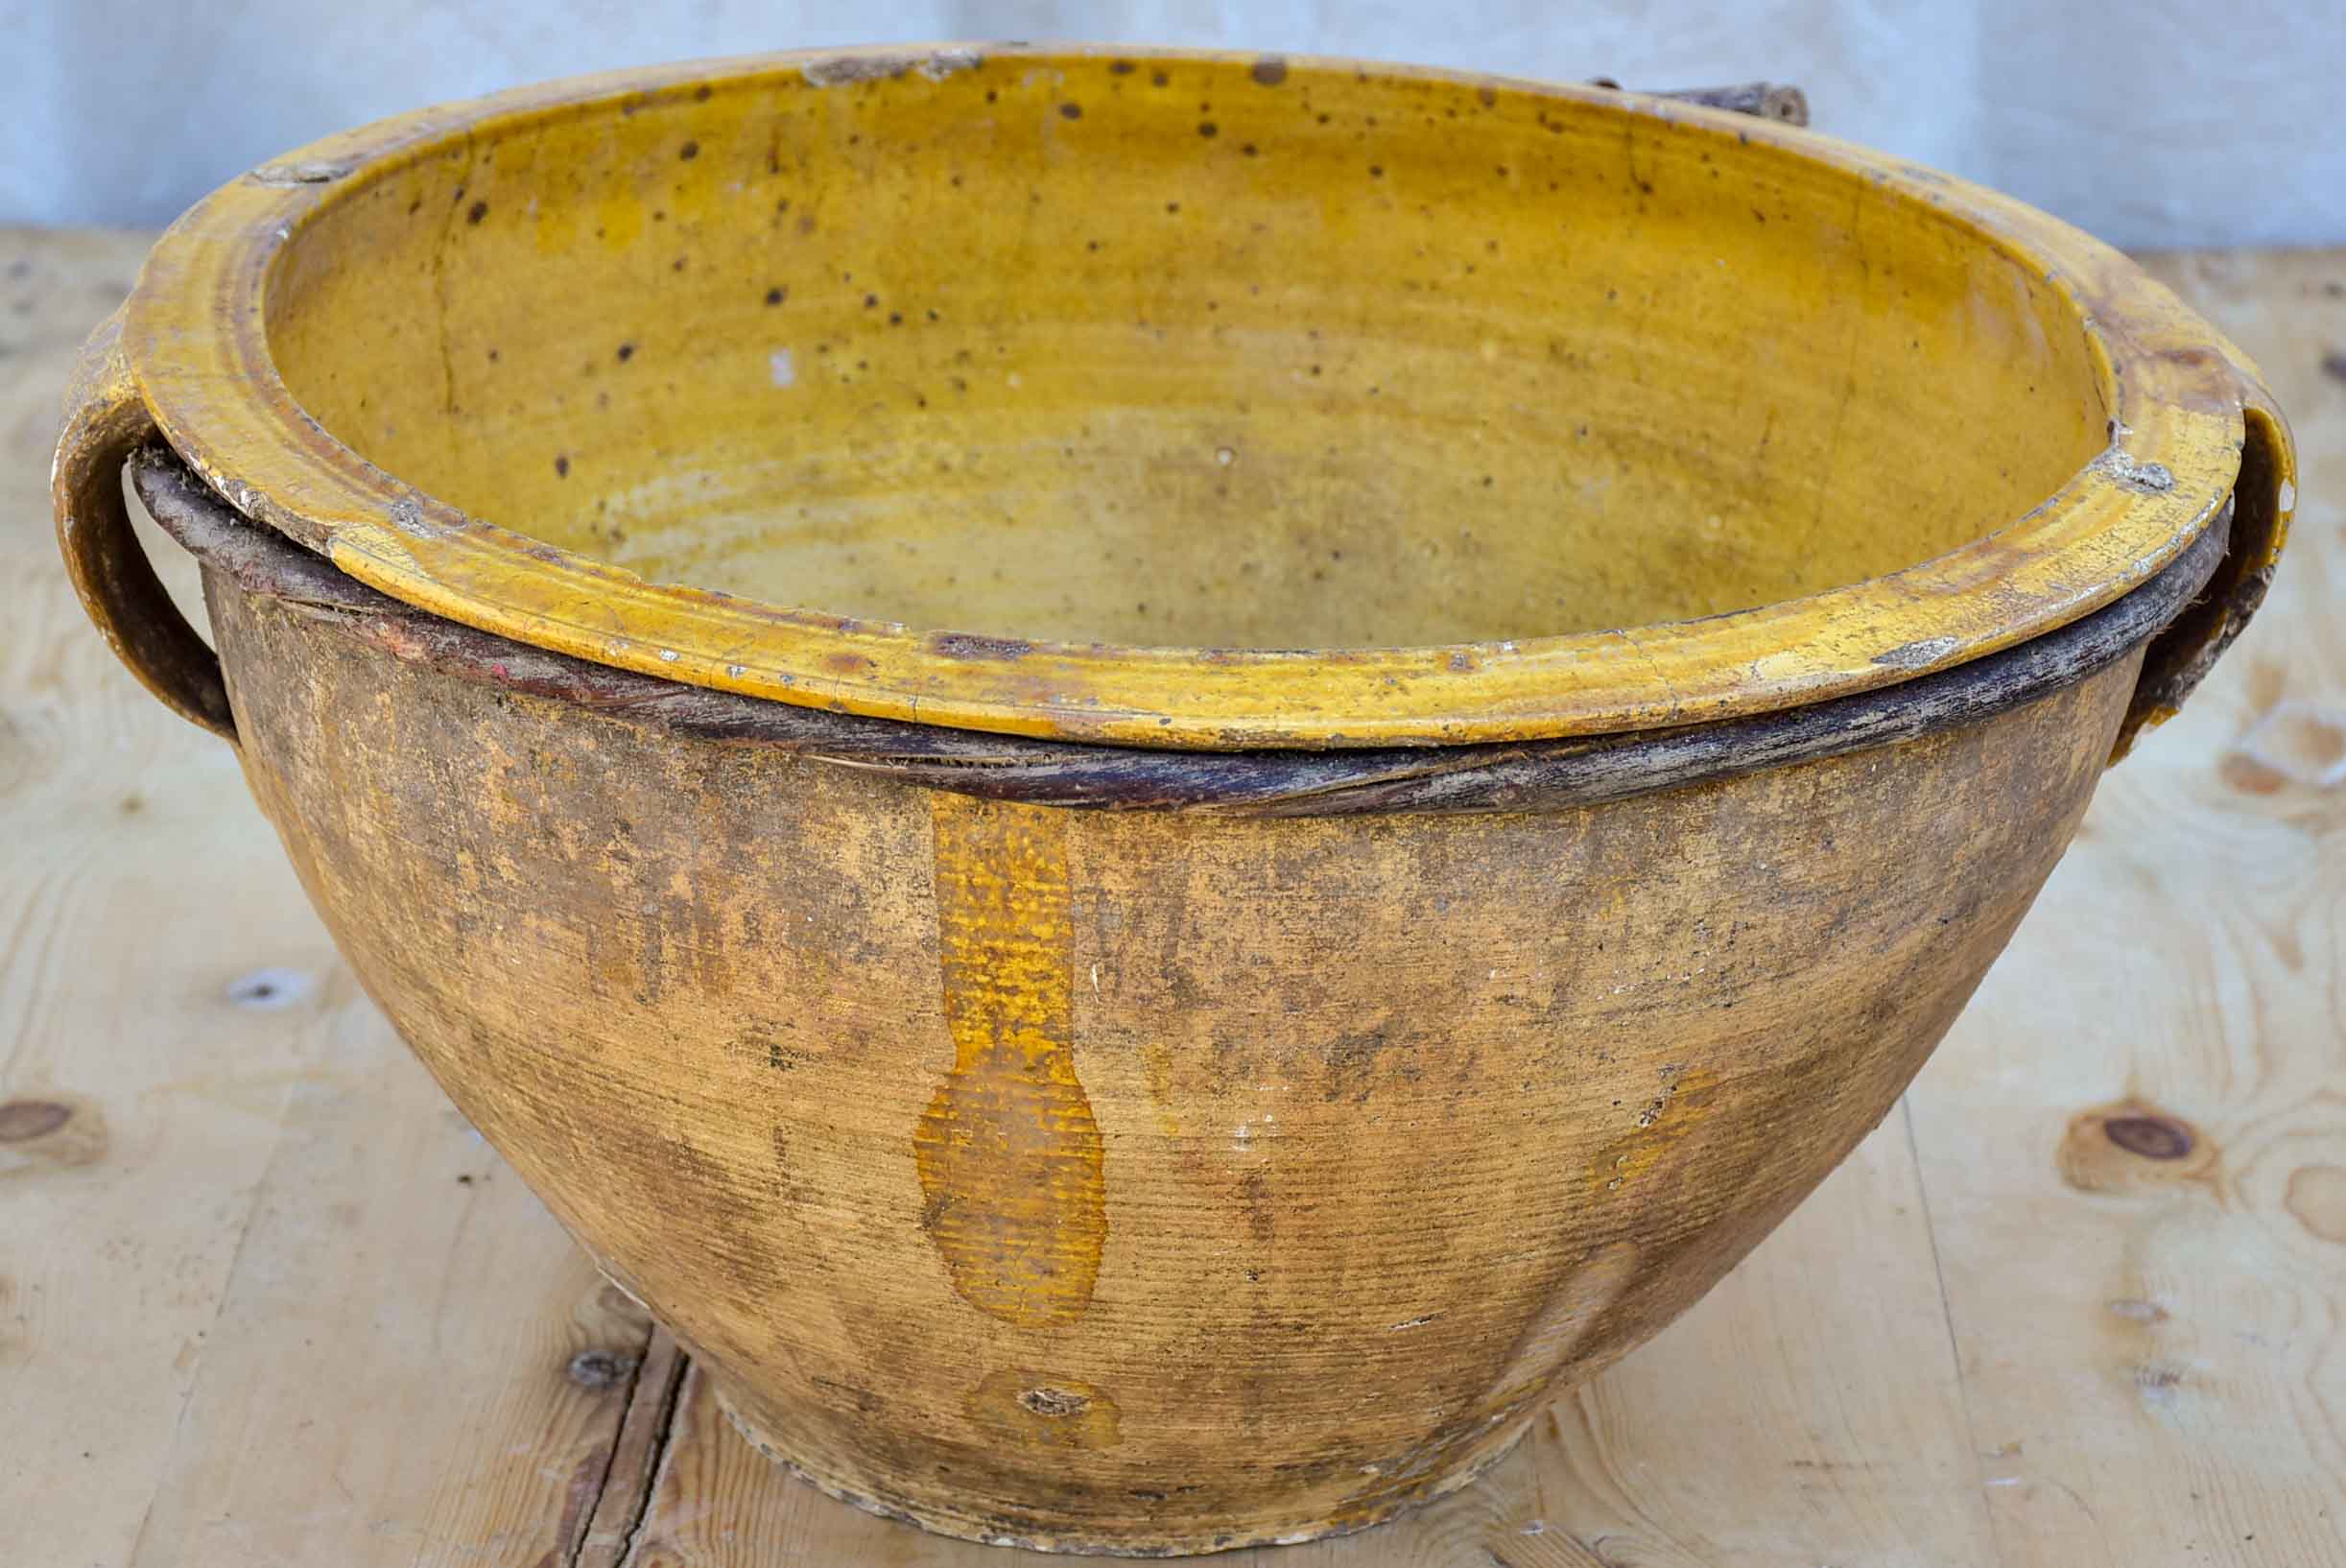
[[131, 443, 2245, 817]]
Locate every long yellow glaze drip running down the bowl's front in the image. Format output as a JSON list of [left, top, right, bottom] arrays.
[[912, 794, 1107, 1328]]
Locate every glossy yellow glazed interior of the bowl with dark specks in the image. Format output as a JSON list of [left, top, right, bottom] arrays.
[[268, 54, 2109, 648]]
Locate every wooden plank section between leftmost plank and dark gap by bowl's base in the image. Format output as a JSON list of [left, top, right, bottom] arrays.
[[116, 1004, 650, 1568]]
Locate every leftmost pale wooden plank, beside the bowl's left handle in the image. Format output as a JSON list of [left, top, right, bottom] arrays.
[[0, 232, 335, 1563]]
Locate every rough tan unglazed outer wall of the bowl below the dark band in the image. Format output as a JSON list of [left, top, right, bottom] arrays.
[[206, 570, 2140, 1552]]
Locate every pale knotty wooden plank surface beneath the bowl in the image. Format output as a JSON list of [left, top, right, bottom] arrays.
[[0, 230, 2346, 1568]]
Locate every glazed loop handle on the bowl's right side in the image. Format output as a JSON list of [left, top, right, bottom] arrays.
[[2109, 361, 2297, 763]]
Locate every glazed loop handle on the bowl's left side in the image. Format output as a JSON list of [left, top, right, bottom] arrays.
[[49, 310, 237, 742]]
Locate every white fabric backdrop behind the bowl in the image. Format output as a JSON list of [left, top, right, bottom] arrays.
[[0, 0, 2346, 247]]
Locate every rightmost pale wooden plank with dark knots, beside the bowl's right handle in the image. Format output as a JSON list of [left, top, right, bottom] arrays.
[[1908, 251, 2346, 1568]]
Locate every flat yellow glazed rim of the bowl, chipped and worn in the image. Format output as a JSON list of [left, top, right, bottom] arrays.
[[122, 44, 2271, 751]]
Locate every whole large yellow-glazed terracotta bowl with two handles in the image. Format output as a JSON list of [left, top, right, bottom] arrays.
[[57, 49, 2289, 1554]]
